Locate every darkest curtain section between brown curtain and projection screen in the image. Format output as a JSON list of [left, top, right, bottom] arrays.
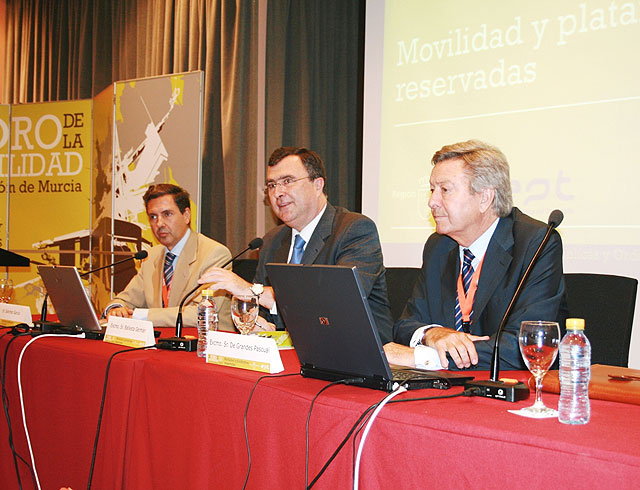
[[266, 0, 365, 218]]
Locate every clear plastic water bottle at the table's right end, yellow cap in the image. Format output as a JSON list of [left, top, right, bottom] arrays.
[[558, 318, 591, 424]]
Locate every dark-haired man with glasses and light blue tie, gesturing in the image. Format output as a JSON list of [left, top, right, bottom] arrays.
[[200, 147, 393, 344]]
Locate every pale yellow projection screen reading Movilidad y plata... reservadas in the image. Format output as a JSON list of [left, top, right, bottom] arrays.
[[362, 0, 640, 365]]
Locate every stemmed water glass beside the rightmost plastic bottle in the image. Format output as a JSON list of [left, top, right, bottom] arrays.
[[518, 321, 560, 417]]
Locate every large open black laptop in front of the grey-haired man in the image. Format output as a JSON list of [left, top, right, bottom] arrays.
[[266, 264, 473, 391]]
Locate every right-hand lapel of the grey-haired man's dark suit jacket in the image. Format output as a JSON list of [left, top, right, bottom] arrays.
[[473, 217, 514, 318]]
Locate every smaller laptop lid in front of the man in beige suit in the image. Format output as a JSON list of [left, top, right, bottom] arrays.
[[38, 265, 102, 332]]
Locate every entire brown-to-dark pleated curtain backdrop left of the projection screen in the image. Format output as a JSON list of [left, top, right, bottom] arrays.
[[2, 0, 364, 250]]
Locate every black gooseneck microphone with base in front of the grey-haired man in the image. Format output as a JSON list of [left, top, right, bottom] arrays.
[[465, 209, 564, 402]]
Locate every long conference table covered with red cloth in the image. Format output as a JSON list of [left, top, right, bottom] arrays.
[[0, 329, 640, 490]]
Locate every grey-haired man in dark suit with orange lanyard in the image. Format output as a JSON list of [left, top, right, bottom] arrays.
[[385, 140, 564, 369]]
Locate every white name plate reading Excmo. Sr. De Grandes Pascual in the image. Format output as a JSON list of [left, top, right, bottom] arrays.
[[206, 332, 284, 374]]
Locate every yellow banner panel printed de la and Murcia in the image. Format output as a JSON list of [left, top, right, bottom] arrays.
[[0, 100, 92, 313]]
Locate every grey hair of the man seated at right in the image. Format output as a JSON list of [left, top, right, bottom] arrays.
[[431, 140, 513, 214]]
